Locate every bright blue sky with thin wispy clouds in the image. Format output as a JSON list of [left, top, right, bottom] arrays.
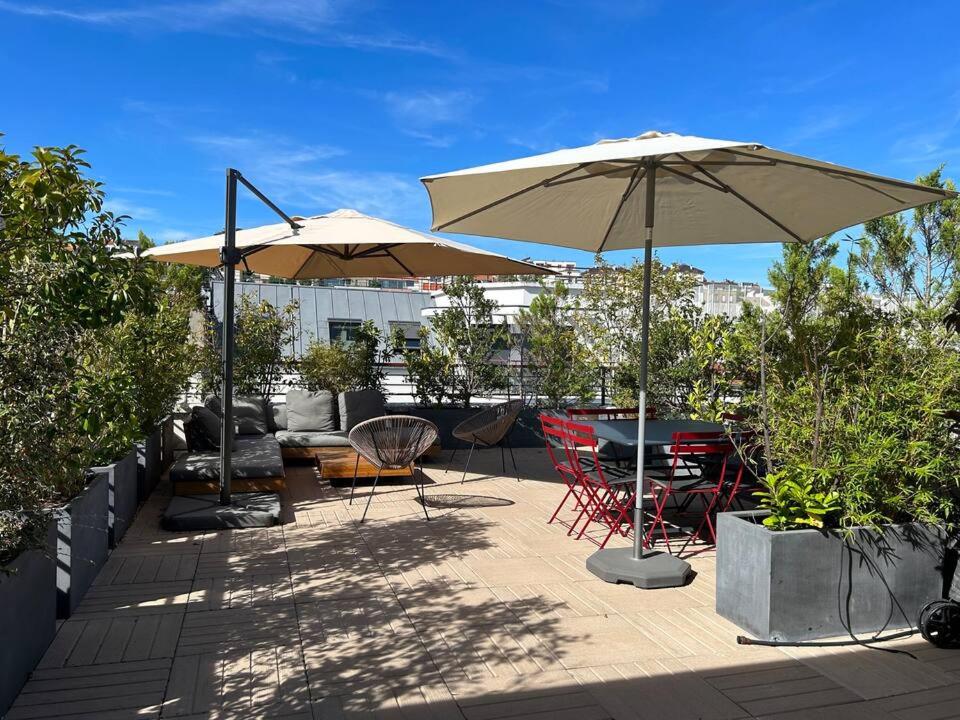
[[0, 0, 960, 281]]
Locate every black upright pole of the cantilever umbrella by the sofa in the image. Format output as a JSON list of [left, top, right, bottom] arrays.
[[220, 168, 239, 505]]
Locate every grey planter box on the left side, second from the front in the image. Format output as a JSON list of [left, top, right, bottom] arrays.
[[57, 475, 109, 618]]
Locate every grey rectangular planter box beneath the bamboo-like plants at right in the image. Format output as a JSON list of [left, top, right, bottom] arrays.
[[716, 510, 944, 641]]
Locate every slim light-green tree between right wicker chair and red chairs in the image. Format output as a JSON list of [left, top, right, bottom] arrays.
[[516, 283, 597, 408]]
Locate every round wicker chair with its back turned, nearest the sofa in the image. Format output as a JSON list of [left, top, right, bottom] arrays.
[[349, 415, 440, 522]]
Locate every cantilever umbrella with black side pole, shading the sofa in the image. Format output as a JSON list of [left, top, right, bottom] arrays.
[[144, 168, 552, 528]]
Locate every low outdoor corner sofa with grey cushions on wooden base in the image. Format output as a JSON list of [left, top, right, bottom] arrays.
[[170, 389, 386, 495]]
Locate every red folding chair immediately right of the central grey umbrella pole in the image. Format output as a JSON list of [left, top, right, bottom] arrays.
[[646, 432, 733, 554]]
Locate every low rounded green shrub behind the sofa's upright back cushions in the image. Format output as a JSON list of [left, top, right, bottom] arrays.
[[300, 320, 387, 395]]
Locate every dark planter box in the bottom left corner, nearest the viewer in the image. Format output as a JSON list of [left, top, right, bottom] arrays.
[[0, 522, 57, 717]]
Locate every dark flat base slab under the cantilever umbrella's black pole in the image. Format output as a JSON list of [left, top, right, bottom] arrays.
[[160, 493, 280, 531]]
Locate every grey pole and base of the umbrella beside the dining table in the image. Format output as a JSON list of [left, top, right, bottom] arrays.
[[587, 158, 692, 590]]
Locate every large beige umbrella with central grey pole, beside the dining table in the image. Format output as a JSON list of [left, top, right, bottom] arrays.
[[422, 131, 954, 588]]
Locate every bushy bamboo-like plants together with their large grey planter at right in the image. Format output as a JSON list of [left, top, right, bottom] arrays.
[[716, 236, 960, 641]]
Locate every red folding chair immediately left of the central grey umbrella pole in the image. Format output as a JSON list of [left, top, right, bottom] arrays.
[[565, 421, 637, 548]]
